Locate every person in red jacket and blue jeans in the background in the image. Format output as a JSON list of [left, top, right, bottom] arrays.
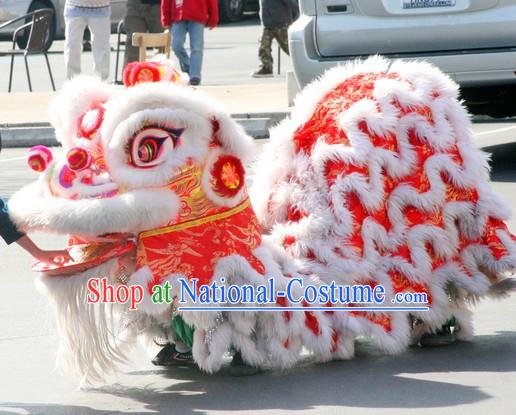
[[161, 0, 219, 85]]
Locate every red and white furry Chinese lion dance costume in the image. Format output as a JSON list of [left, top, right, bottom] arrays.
[[10, 58, 516, 386]]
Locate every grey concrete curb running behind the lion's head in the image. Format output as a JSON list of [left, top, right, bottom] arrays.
[[0, 112, 289, 148]]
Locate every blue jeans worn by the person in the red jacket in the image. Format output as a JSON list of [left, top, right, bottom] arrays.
[[170, 20, 204, 80]]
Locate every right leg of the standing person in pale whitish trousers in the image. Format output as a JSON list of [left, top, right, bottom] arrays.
[[88, 16, 111, 81]]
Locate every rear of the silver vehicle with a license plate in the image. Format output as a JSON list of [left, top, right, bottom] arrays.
[[289, 0, 516, 87]]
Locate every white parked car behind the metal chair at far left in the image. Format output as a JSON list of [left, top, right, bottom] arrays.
[[0, 0, 127, 47]]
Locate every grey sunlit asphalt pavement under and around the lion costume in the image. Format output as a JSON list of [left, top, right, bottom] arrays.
[[0, 125, 516, 415]]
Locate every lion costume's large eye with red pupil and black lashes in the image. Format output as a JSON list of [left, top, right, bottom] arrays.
[[131, 128, 183, 168]]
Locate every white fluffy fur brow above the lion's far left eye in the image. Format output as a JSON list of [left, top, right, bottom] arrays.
[[49, 76, 117, 147]]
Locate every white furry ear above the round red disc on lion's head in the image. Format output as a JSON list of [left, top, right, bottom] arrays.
[[211, 112, 255, 164]]
